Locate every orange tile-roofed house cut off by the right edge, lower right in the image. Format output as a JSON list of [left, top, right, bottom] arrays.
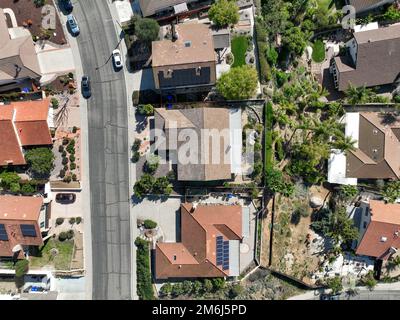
[[356, 200, 400, 260]]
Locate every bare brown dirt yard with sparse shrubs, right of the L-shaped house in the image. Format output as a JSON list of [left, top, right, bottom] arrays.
[[261, 184, 329, 284]]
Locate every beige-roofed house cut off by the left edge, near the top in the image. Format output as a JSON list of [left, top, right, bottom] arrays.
[[0, 8, 42, 92]]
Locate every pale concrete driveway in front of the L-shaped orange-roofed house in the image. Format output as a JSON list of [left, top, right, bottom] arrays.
[[133, 198, 181, 242]]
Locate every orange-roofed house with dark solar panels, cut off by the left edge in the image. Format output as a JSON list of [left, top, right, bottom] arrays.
[[0, 195, 50, 259]]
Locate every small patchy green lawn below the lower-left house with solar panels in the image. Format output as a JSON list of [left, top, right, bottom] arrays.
[[29, 239, 74, 270]]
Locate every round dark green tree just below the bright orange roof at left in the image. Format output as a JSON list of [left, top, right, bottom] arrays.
[[25, 148, 55, 176]]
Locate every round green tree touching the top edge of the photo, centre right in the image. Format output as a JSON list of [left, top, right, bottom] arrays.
[[208, 0, 240, 28]]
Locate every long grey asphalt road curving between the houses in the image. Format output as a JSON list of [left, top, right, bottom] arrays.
[[73, 0, 132, 300]]
